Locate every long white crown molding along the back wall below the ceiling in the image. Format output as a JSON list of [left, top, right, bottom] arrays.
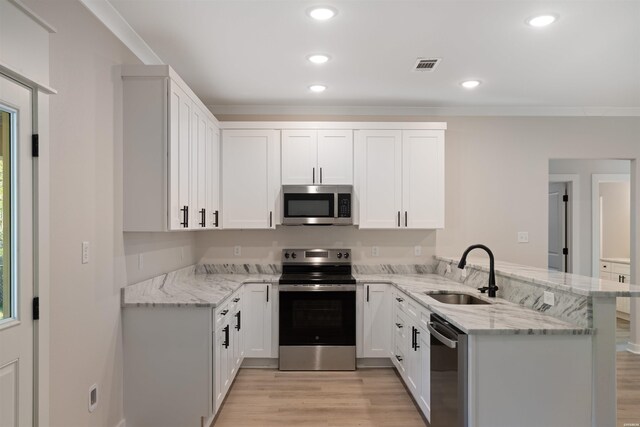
[[209, 103, 640, 117]]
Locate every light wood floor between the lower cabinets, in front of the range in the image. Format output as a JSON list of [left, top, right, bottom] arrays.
[[213, 369, 427, 427]]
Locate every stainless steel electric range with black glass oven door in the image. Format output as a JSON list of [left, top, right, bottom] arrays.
[[279, 249, 356, 371]]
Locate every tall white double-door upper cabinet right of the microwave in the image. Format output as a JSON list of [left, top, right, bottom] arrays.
[[355, 130, 444, 229]]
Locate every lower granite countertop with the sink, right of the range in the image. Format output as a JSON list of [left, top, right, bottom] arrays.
[[355, 274, 592, 335]]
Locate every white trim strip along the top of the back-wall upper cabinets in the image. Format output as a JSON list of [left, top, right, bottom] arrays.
[[220, 121, 447, 130]]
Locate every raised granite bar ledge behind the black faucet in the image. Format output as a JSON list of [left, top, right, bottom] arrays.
[[435, 256, 640, 297]]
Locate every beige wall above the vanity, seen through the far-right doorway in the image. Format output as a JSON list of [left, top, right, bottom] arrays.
[[600, 182, 631, 258]]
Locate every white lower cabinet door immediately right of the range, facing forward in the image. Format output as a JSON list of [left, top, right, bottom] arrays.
[[363, 283, 391, 357]]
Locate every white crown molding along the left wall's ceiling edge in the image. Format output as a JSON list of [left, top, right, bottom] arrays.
[[80, 0, 163, 65]]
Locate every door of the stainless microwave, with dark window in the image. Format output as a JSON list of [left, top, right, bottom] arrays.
[[282, 192, 337, 225]]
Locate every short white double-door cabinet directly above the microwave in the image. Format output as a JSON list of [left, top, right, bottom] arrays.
[[282, 129, 353, 185]]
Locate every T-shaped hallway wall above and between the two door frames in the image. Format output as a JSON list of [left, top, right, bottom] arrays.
[[549, 159, 640, 276]]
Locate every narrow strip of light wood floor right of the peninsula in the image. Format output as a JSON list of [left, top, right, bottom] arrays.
[[616, 351, 640, 427]]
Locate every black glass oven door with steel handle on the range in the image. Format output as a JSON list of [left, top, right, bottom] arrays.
[[279, 285, 356, 347]]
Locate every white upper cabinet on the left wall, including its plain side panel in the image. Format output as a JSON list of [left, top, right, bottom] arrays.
[[121, 65, 220, 231]]
